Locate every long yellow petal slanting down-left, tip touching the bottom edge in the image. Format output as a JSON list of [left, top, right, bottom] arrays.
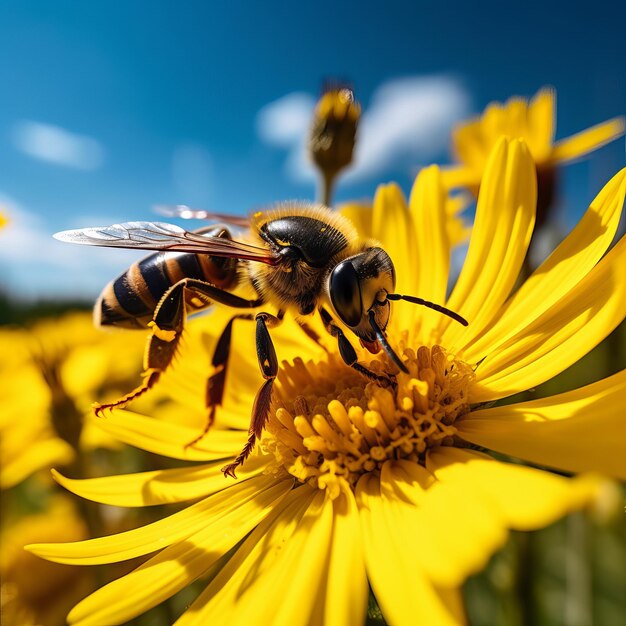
[[60, 478, 292, 626]]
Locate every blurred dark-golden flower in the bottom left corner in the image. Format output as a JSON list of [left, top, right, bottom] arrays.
[[0, 497, 95, 626]]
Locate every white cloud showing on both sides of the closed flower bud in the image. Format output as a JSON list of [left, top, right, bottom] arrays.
[[257, 75, 470, 181]]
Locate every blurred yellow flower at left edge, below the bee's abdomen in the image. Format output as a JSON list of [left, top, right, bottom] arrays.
[[0, 313, 145, 488]]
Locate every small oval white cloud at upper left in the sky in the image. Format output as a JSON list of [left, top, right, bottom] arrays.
[[12, 120, 104, 170]]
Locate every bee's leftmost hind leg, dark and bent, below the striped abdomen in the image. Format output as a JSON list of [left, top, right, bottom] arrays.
[[94, 281, 185, 417]]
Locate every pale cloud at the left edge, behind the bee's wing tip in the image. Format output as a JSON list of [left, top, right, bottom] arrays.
[[0, 193, 138, 301]]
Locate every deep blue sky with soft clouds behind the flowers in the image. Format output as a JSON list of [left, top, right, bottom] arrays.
[[0, 0, 626, 298]]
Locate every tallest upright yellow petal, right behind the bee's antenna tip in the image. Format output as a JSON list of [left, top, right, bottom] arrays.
[[440, 138, 537, 349]]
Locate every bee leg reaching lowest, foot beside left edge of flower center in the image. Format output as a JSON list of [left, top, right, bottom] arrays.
[[222, 312, 283, 478]]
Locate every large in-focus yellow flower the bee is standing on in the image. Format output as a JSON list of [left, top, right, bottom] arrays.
[[29, 140, 626, 626]]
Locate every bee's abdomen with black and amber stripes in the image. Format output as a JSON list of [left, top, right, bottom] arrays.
[[94, 229, 238, 328]]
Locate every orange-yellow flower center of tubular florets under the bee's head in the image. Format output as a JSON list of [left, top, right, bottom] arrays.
[[261, 338, 473, 497]]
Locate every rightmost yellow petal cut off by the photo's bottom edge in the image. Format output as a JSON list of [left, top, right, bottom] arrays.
[[356, 474, 464, 626]]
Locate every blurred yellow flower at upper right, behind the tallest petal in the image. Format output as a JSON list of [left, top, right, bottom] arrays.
[[443, 88, 624, 194]]
